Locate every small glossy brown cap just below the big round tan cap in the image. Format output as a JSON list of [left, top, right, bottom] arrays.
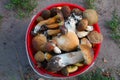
[[77, 19, 88, 31]]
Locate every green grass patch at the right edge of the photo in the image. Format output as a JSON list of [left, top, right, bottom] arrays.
[[106, 10, 120, 43]]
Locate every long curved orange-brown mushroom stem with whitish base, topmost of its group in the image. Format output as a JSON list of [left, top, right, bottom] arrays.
[[33, 14, 63, 34]]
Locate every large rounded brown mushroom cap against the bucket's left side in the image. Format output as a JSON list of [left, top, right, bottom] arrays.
[[32, 34, 47, 51]]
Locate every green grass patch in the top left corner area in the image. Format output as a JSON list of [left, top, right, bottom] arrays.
[[5, 0, 37, 18]]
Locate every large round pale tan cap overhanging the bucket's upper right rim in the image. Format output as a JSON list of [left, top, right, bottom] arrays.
[[83, 9, 98, 26]]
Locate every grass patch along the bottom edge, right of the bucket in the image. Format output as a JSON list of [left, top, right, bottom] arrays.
[[78, 68, 115, 80]]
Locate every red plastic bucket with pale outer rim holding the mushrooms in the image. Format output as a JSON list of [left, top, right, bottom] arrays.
[[25, 3, 101, 78]]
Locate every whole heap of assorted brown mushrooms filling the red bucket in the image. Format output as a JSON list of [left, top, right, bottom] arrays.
[[31, 6, 103, 76]]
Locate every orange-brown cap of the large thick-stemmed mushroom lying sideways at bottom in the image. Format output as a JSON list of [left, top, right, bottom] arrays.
[[80, 45, 94, 65]]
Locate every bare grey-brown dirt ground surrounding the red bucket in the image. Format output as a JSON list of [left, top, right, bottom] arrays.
[[0, 0, 120, 80]]
